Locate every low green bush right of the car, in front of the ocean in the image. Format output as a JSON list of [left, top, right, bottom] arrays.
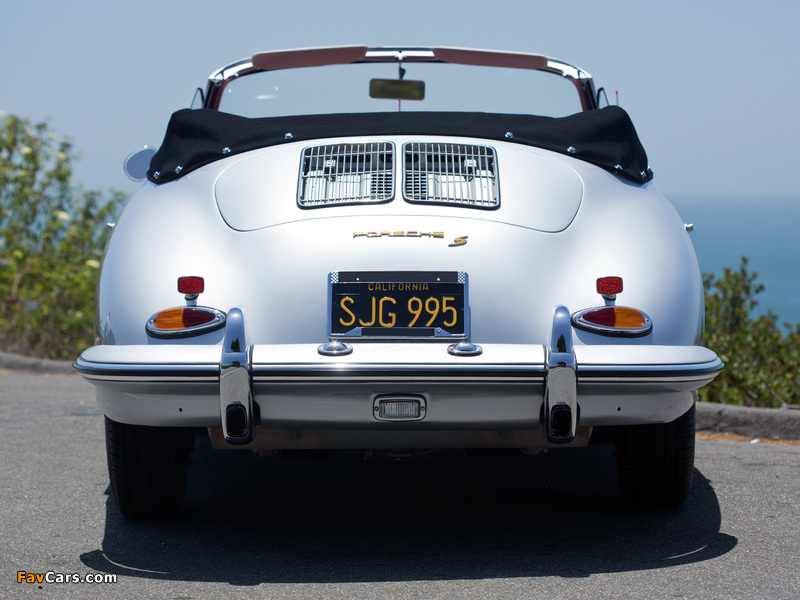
[[700, 257, 800, 407]]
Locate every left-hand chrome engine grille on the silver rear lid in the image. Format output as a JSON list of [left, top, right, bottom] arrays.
[[297, 142, 394, 208]]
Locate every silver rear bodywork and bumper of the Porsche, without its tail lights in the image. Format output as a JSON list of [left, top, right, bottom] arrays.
[[78, 130, 719, 448]]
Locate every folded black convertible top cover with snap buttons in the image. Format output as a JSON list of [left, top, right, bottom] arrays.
[[147, 106, 653, 184]]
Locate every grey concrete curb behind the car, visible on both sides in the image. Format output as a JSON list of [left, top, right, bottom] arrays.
[[0, 352, 800, 440]]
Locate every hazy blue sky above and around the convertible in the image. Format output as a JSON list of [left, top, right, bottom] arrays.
[[0, 0, 800, 201]]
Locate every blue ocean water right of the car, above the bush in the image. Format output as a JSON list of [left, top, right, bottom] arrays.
[[670, 197, 800, 326]]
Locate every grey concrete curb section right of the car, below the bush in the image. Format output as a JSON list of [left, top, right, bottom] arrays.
[[697, 402, 800, 440]]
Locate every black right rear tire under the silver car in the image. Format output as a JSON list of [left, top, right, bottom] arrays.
[[615, 404, 695, 508]]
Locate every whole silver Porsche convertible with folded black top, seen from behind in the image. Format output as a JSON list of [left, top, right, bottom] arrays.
[[75, 46, 722, 518]]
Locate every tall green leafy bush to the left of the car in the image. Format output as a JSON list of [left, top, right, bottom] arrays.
[[0, 113, 123, 359]]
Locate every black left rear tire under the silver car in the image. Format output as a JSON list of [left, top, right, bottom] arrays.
[[106, 417, 194, 519]]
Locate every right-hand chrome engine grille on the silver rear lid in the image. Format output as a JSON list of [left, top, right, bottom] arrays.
[[403, 142, 500, 208]]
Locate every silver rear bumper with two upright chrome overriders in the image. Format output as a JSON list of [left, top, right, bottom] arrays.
[[74, 307, 723, 449]]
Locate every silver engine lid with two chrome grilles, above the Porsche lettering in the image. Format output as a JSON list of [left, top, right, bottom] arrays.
[[215, 137, 592, 233]]
